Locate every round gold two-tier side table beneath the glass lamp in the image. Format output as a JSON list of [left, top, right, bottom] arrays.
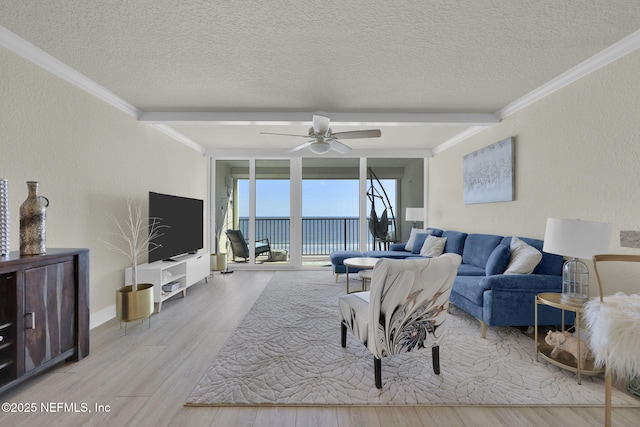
[[535, 292, 604, 384]]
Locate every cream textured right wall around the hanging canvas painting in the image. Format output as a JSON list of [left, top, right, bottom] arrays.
[[429, 47, 640, 295]]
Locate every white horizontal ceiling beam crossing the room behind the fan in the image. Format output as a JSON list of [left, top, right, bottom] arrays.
[[139, 111, 500, 126]]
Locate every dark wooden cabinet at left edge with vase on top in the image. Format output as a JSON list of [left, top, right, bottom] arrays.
[[0, 249, 89, 393]]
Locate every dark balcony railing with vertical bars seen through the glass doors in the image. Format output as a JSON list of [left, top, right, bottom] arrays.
[[239, 217, 395, 255]]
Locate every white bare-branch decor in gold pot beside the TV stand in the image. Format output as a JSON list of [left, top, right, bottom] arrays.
[[104, 199, 167, 322]]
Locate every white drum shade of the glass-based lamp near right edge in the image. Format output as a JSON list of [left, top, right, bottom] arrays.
[[542, 218, 612, 259]]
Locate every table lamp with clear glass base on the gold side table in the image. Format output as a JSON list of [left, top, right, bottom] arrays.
[[542, 218, 611, 305]]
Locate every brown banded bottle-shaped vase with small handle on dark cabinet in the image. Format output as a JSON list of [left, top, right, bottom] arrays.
[[20, 181, 49, 255]]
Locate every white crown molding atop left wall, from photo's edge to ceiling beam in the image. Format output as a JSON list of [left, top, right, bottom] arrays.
[[0, 26, 141, 119]]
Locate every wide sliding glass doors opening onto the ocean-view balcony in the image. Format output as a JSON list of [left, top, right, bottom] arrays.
[[212, 157, 426, 269]]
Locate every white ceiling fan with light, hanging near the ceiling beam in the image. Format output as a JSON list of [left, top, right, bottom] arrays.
[[261, 114, 382, 154]]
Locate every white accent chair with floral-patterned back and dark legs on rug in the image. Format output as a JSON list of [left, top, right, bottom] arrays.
[[339, 254, 462, 388]]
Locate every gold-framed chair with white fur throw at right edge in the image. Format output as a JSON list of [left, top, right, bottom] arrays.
[[584, 254, 640, 427]]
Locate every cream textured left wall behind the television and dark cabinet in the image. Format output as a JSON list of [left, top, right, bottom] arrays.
[[0, 49, 208, 321]]
